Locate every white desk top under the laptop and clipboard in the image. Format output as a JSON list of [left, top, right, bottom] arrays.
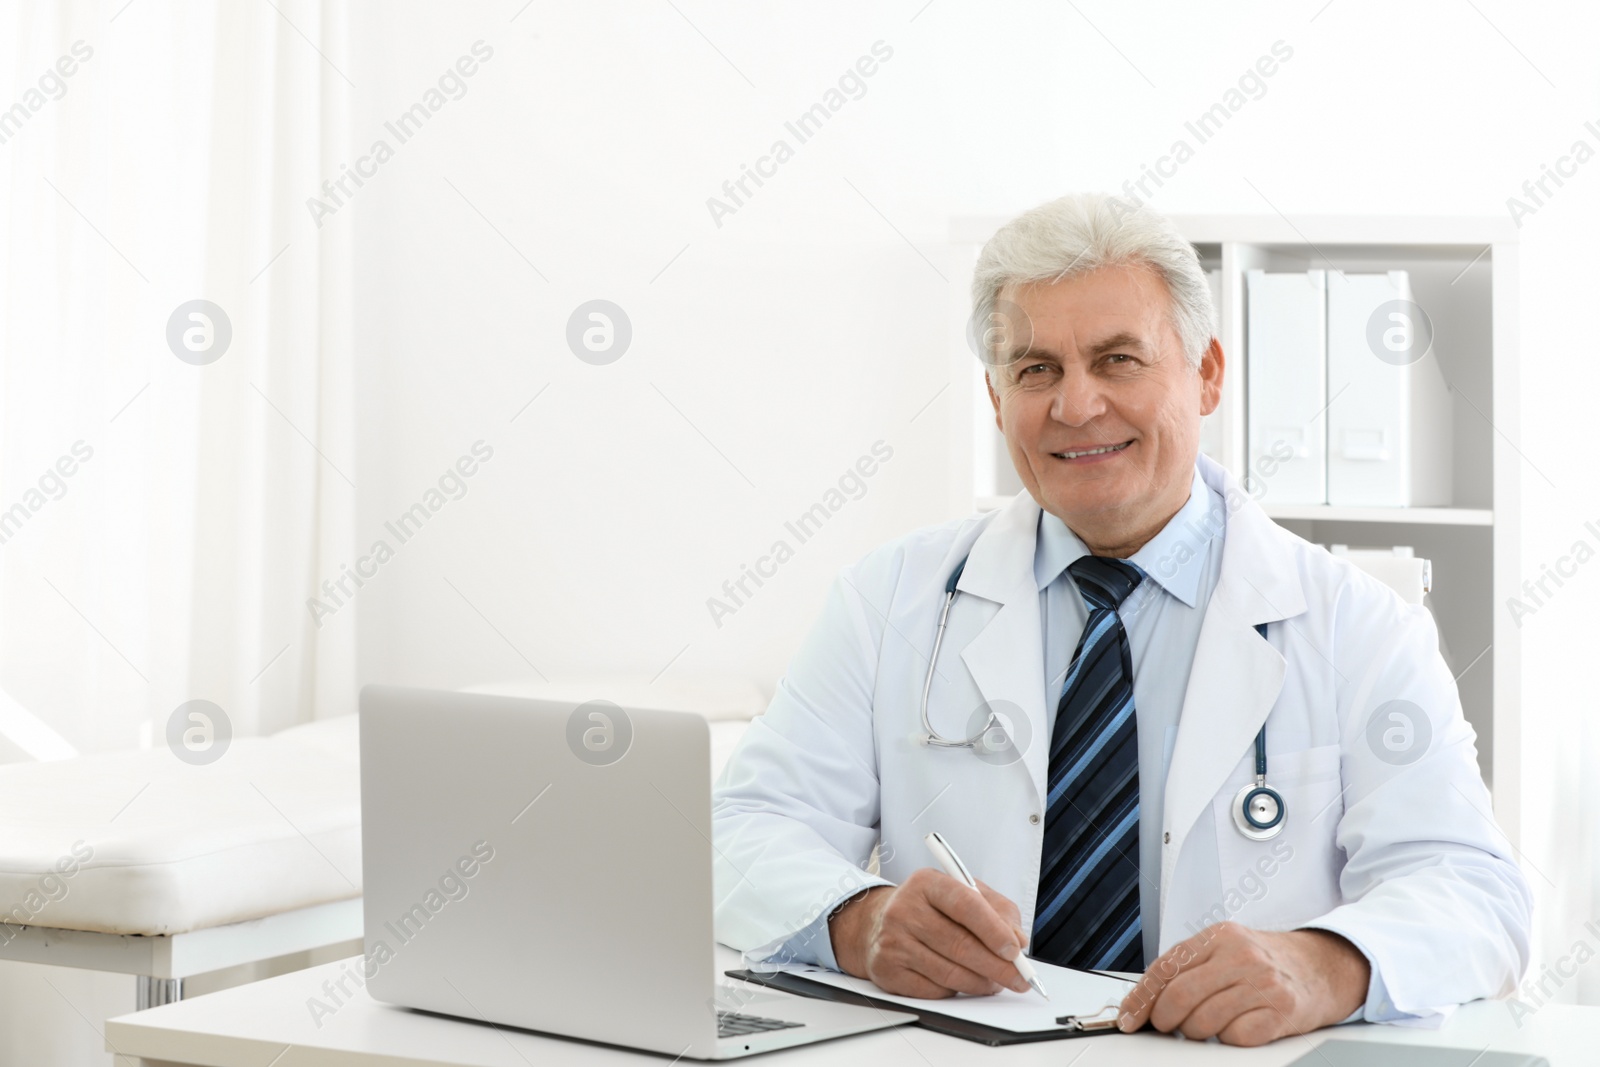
[[106, 949, 1600, 1067]]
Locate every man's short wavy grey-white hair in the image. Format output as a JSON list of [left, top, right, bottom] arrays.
[[973, 192, 1216, 381]]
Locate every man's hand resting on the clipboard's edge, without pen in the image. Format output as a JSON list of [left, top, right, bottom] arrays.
[[1117, 923, 1371, 1045]]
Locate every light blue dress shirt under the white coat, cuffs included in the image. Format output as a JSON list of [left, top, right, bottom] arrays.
[[771, 469, 1414, 1022]]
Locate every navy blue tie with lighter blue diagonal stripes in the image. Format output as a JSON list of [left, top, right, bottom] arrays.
[[1029, 555, 1144, 971]]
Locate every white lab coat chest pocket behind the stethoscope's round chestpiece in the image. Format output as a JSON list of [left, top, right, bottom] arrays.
[[1205, 744, 1344, 929]]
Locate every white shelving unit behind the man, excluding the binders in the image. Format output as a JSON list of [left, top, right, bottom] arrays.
[[949, 216, 1523, 843]]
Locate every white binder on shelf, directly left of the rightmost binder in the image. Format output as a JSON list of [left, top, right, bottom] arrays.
[[1245, 270, 1330, 504]]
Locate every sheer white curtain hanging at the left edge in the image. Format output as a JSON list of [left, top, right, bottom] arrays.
[[0, 0, 355, 760]]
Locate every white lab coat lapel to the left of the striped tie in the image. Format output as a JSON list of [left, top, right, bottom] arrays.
[[957, 491, 1050, 797]]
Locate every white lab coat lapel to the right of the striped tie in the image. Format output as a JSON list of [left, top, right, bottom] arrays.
[[1162, 456, 1306, 928]]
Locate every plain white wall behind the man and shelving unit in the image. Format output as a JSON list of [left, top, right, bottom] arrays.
[[326, 0, 1600, 1000]]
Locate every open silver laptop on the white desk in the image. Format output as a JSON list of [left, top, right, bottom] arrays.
[[360, 686, 915, 1059]]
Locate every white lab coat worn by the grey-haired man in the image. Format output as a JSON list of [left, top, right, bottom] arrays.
[[714, 456, 1531, 1017]]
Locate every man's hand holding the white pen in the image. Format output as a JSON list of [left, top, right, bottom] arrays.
[[829, 867, 1029, 1000]]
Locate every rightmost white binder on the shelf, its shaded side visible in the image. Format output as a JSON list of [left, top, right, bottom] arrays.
[[1328, 270, 1451, 507]]
